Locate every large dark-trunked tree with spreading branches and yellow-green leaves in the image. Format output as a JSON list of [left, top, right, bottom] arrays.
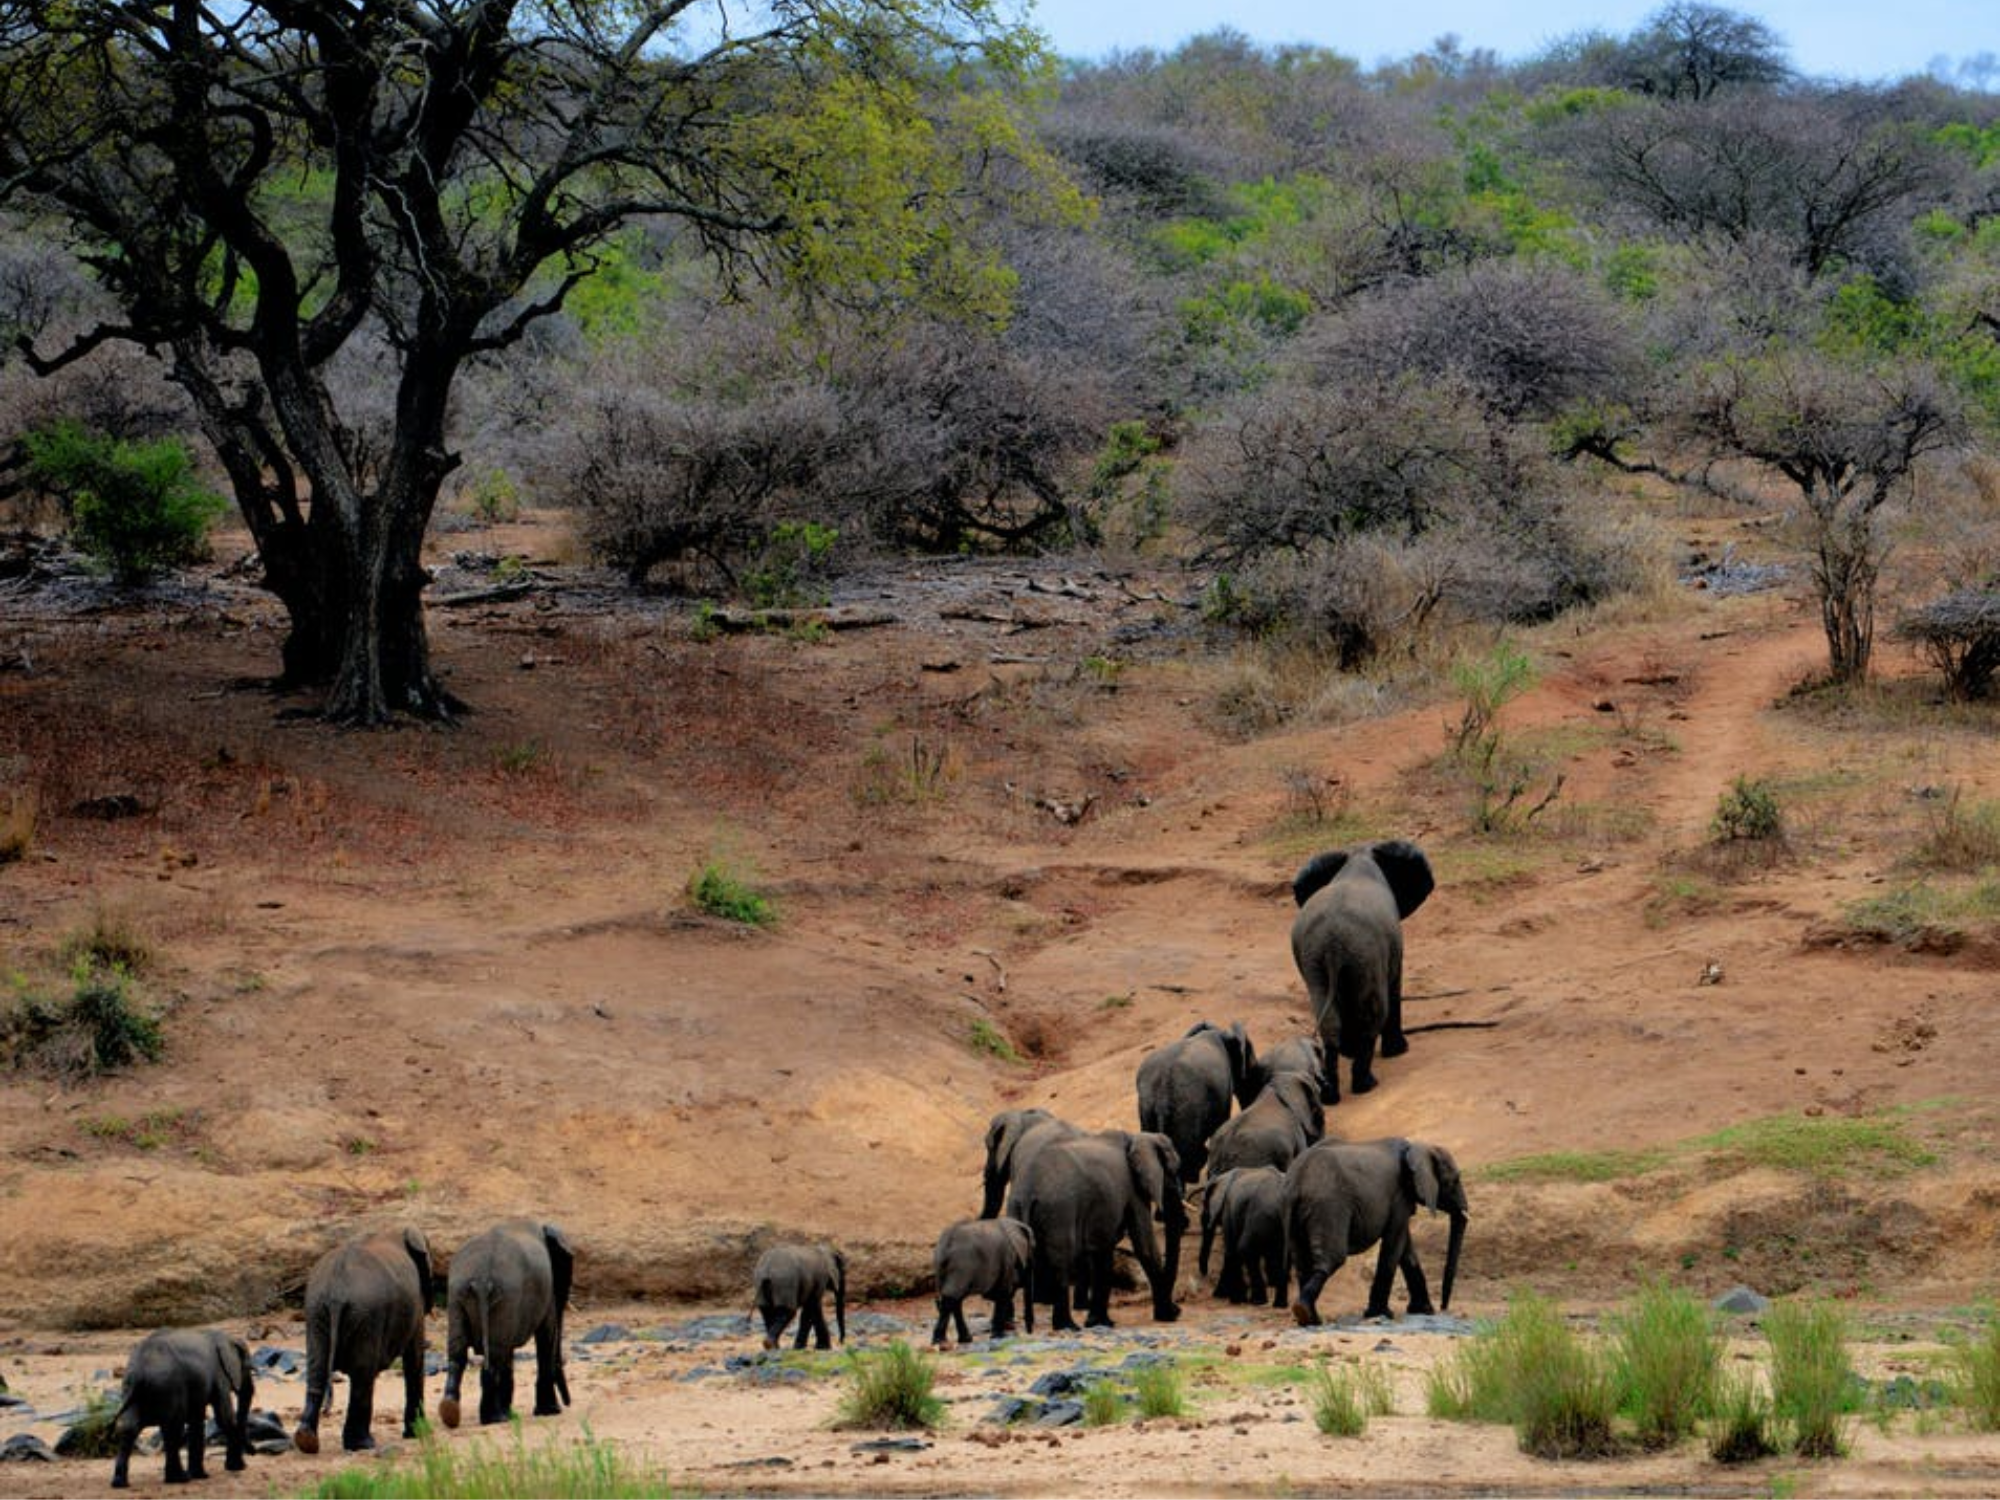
[[0, 0, 1046, 722]]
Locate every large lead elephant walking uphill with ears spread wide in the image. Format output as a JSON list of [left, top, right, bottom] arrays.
[[1292, 838, 1438, 1104]]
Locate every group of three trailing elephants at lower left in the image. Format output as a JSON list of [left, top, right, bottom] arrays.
[[112, 1218, 574, 1490]]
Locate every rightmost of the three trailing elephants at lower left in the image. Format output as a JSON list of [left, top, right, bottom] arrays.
[[438, 1218, 576, 1428]]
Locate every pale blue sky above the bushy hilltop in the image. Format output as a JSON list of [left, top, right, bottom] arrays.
[[1030, 0, 2000, 88]]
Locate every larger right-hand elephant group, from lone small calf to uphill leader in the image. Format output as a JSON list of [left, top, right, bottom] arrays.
[[780, 840, 1468, 1348]]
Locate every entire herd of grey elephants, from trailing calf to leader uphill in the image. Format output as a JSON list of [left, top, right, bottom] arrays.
[[112, 840, 1466, 1488]]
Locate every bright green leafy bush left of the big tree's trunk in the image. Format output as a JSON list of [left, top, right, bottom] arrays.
[[24, 422, 228, 584]]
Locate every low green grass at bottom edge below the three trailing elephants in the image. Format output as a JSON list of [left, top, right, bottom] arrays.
[[306, 1420, 670, 1500]]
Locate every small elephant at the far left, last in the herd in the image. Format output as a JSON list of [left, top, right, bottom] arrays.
[[112, 1328, 256, 1490]]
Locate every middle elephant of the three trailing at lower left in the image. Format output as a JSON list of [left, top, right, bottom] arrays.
[[292, 1230, 432, 1454]]
